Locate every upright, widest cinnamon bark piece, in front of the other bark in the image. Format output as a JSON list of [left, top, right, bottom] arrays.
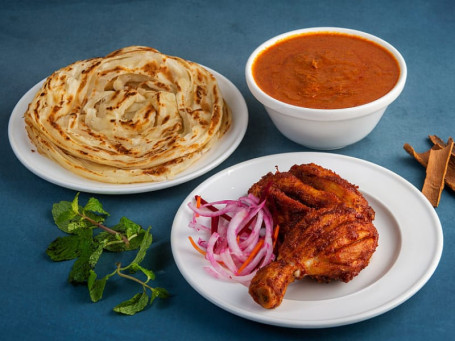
[[422, 138, 453, 207]]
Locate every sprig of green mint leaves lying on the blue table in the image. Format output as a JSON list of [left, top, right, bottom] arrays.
[[46, 193, 169, 315]]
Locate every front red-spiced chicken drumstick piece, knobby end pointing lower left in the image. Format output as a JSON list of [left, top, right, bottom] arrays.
[[249, 205, 378, 309]]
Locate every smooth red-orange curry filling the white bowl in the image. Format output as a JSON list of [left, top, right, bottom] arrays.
[[253, 32, 400, 109]]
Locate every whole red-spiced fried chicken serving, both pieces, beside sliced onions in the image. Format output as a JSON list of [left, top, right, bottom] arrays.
[[249, 164, 378, 308]]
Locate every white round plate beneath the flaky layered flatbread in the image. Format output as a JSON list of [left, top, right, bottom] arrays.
[[8, 68, 248, 194]]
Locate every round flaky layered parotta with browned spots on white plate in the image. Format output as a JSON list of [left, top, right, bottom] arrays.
[[25, 46, 231, 183]]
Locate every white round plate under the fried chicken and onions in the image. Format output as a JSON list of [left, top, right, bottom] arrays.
[[171, 153, 443, 328]]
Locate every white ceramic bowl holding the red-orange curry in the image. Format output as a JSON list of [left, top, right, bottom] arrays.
[[245, 27, 407, 150]]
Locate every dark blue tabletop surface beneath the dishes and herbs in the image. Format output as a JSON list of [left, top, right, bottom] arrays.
[[0, 0, 455, 340]]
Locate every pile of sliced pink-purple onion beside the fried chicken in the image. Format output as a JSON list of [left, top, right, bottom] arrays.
[[188, 194, 275, 285]]
